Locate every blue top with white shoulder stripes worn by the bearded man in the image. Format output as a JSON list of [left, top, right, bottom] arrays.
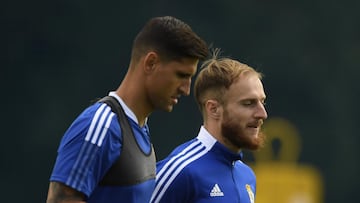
[[151, 127, 256, 203]]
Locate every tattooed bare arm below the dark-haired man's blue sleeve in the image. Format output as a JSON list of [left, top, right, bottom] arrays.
[[46, 182, 86, 203]]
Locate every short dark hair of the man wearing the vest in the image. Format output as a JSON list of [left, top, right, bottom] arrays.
[[132, 16, 208, 61]]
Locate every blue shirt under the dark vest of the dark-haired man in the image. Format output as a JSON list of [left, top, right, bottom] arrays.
[[50, 92, 155, 203]]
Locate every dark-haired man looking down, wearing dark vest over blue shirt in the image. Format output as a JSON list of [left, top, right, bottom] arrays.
[[47, 16, 208, 203]]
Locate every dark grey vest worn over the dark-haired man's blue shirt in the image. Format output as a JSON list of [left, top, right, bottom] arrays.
[[99, 96, 156, 185]]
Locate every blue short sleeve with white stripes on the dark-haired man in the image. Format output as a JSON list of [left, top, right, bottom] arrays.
[[50, 103, 121, 196]]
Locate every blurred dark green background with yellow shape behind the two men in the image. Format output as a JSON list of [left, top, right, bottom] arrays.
[[0, 0, 360, 203]]
